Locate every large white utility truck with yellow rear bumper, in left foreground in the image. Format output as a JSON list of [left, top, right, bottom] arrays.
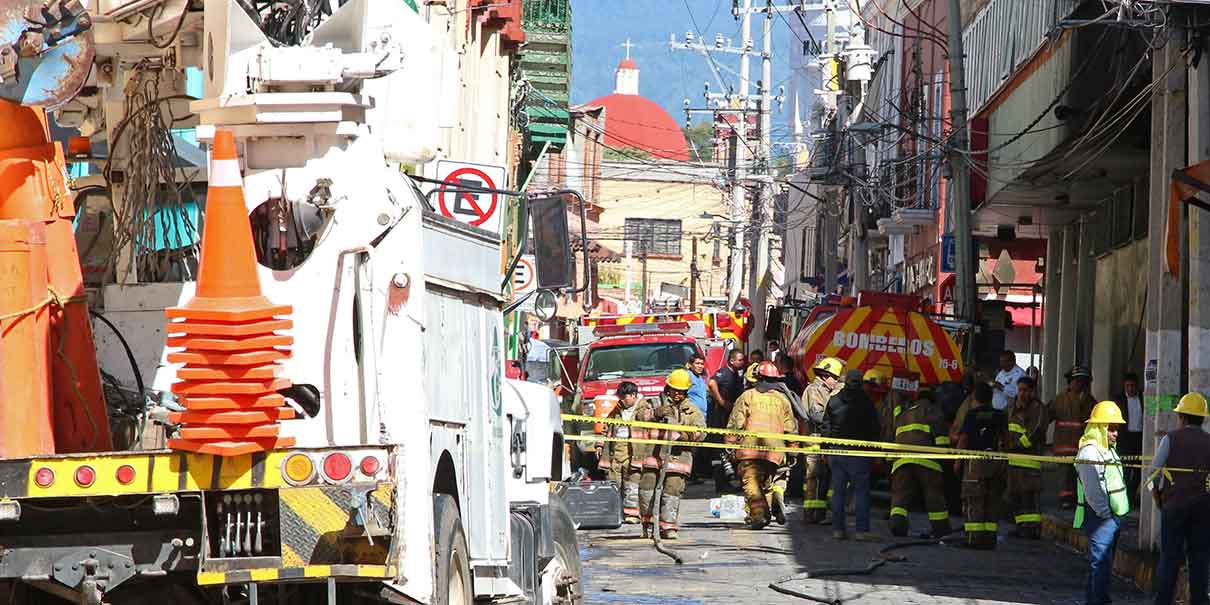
[[0, 0, 582, 605]]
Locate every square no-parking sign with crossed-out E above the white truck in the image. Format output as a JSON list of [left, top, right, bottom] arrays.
[[437, 160, 505, 234]]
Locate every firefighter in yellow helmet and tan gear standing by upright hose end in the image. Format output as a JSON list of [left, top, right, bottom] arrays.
[[634, 368, 705, 540]]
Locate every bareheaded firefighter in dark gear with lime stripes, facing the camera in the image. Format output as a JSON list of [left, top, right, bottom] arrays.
[[1003, 375, 1049, 540]]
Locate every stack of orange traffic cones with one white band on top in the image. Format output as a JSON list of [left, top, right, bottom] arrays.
[[167, 131, 294, 456]]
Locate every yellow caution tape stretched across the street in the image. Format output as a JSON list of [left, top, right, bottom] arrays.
[[561, 414, 1180, 472]]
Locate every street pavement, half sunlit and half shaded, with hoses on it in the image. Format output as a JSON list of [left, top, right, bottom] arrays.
[[578, 485, 1145, 605]]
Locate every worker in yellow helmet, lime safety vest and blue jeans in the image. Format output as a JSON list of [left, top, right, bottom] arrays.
[[1072, 402, 1130, 605]]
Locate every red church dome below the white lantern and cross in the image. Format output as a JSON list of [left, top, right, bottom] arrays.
[[588, 93, 688, 162]]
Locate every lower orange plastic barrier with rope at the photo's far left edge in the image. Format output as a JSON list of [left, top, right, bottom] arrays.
[[0, 220, 54, 457]]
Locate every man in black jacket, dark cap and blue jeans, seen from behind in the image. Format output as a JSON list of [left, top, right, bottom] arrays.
[[820, 370, 881, 541]]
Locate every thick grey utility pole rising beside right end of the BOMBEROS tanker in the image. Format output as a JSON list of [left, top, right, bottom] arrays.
[[946, 0, 976, 346]]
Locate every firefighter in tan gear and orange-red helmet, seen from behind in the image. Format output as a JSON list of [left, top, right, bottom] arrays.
[[726, 361, 799, 529]]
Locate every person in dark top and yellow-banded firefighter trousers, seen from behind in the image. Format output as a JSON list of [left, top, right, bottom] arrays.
[[955, 382, 1008, 551]]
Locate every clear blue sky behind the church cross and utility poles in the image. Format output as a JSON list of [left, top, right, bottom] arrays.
[[571, 0, 800, 156]]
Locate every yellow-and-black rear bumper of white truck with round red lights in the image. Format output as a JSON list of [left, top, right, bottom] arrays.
[[0, 448, 397, 589]]
